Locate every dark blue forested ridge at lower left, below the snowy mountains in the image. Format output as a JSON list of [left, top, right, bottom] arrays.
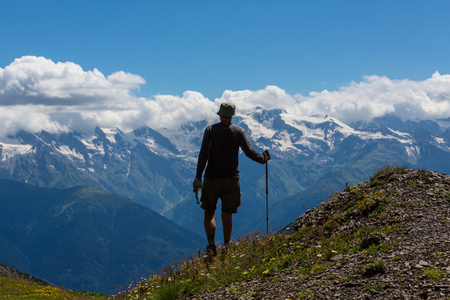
[[0, 179, 203, 292]]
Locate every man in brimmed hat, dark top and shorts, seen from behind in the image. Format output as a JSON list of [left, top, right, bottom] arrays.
[[193, 103, 270, 255]]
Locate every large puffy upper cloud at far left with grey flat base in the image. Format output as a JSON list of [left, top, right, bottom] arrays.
[[0, 56, 145, 106]]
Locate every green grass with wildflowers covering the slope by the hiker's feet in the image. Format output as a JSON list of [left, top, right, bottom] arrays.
[[118, 167, 450, 299]]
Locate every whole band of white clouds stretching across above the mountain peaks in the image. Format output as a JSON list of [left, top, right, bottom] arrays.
[[0, 56, 450, 136]]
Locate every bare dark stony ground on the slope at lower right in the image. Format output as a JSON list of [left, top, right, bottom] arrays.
[[192, 170, 450, 299]]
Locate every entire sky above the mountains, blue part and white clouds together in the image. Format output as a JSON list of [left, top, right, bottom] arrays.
[[0, 0, 450, 137]]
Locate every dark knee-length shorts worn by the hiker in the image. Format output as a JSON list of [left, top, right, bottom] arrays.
[[200, 178, 241, 214]]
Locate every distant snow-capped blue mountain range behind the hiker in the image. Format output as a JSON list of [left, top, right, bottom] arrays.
[[0, 107, 450, 234]]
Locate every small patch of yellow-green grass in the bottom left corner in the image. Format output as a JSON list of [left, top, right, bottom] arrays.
[[0, 276, 108, 300]]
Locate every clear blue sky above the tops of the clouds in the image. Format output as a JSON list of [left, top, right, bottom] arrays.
[[0, 0, 450, 100]]
